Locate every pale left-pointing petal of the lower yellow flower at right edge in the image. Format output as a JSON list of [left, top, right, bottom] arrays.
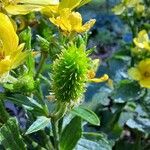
[[128, 67, 142, 80]]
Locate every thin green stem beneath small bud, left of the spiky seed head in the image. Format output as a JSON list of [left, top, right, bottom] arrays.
[[35, 52, 48, 79]]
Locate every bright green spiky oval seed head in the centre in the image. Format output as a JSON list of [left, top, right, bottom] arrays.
[[52, 45, 89, 103]]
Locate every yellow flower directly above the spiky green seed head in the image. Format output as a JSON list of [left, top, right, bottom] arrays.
[[44, 0, 96, 34]]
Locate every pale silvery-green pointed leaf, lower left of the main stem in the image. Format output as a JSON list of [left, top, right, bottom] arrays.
[[26, 116, 50, 134]]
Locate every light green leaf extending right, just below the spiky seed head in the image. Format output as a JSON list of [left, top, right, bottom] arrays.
[[71, 106, 100, 126]]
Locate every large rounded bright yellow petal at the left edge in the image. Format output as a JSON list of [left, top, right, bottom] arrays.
[[0, 13, 18, 55]]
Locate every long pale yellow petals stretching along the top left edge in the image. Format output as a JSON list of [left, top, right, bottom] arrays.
[[0, 0, 59, 15]]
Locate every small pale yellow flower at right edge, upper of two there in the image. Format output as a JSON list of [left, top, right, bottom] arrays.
[[133, 30, 150, 51]]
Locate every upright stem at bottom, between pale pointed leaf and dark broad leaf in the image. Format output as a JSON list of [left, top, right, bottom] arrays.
[[51, 119, 59, 150]]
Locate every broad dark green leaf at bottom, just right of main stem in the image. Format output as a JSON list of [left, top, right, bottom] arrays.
[[60, 117, 82, 150]]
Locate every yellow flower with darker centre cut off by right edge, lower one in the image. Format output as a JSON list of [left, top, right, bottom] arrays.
[[128, 58, 150, 88]]
